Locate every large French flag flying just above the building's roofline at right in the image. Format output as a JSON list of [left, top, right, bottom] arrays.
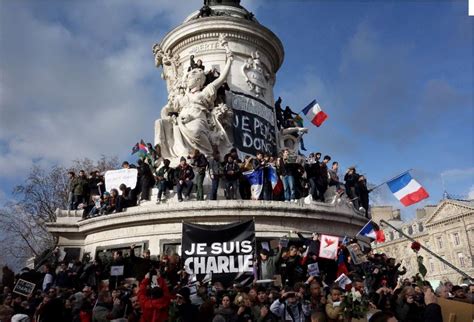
[[387, 172, 430, 207]]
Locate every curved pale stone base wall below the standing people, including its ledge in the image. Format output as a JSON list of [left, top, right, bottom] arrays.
[[48, 200, 367, 256]]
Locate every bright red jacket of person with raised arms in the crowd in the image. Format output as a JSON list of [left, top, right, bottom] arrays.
[[138, 277, 170, 322]]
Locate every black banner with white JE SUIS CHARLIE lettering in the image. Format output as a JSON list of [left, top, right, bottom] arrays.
[[181, 220, 255, 286]]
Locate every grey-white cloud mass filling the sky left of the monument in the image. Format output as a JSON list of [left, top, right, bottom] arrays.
[[0, 0, 201, 177]]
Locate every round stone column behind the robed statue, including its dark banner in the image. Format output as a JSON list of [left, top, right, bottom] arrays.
[[155, 5, 284, 157]]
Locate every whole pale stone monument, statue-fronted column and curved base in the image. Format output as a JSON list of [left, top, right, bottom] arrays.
[[48, 0, 367, 257]]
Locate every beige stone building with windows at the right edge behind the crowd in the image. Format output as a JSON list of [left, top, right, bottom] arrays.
[[372, 199, 474, 284]]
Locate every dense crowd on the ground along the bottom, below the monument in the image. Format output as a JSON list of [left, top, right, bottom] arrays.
[[0, 234, 474, 322]]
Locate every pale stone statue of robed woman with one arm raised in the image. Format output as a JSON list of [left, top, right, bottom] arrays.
[[155, 53, 233, 157]]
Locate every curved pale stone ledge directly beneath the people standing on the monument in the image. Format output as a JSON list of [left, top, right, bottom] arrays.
[[47, 200, 366, 235]]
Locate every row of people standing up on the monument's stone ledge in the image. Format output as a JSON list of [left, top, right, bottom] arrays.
[[69, 144, 370, 217]]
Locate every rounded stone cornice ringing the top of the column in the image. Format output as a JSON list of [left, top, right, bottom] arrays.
[[161, 16, 284, 73]]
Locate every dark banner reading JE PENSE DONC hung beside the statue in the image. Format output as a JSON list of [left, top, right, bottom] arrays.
[[226, 91, 276, 155]]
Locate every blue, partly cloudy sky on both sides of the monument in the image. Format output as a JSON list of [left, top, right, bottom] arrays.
[[0, 0, 474, 218]]
